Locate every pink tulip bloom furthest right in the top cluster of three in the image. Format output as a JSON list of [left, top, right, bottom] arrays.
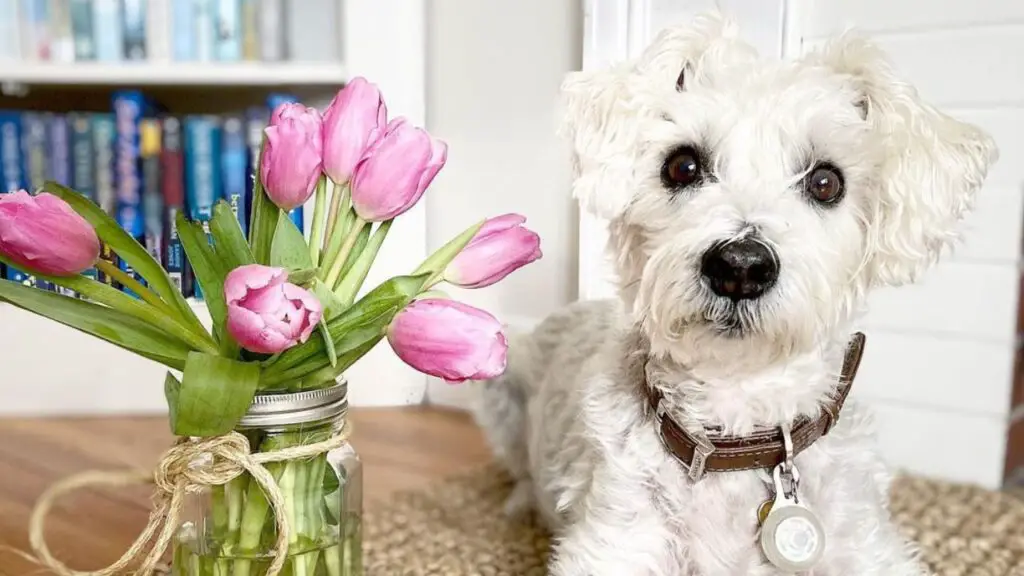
[[352, 118, 447, 222]]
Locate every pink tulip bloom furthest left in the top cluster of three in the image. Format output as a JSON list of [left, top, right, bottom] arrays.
[[260, 102, 324, 210]]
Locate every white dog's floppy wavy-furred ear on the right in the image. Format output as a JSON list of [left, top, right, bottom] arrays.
[[810, 33, 998, 286]]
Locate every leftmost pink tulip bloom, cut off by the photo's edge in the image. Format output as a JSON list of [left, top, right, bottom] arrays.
[[0, 190, 99, 276]]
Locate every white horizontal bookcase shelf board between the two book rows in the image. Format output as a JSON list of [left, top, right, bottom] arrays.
[[0, 61, 347, 86]]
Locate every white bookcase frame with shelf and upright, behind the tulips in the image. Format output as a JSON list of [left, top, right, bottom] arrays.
[[0, 0, 427, 417]]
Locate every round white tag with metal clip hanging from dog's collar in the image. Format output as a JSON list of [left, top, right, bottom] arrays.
[[758, 422, 825, 573]]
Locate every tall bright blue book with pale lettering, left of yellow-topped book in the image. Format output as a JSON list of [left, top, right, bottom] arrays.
[[114, 90, 145, 295]]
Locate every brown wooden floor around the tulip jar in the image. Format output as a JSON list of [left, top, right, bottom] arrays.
[[0, 408, 489, 576]]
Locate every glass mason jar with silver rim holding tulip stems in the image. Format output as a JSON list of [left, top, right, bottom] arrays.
[[172, 381, 362, 576]]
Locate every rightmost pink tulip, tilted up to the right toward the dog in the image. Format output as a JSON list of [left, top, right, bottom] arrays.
[[444, 214, 542, 288]]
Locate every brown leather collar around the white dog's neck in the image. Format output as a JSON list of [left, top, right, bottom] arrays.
[[644, 332, 865, 482]]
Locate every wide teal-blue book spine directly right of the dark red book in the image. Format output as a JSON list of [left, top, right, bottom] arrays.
[[184, 116, 221, 299]]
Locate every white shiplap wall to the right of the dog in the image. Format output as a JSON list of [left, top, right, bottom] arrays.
[[786, 0, 1024, 487]]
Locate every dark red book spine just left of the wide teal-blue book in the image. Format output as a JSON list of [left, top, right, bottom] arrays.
[[160, 116, 191, 297]]
